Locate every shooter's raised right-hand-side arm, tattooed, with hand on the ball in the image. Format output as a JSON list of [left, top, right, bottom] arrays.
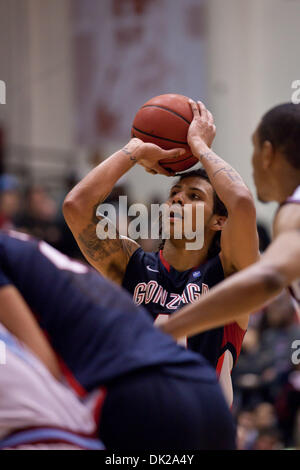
[[189, 102, 259, 329]]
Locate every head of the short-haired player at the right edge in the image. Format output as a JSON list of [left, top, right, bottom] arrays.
[[252, 103, 300, 202]]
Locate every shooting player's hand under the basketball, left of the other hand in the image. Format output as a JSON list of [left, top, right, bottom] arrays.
[[135, 141, 186, 176]]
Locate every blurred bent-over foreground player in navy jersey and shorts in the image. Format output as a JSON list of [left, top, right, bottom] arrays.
[[0, 232, 235, 450]]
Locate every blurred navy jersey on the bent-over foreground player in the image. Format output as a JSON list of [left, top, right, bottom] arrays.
[[0, 232, 216, 391]]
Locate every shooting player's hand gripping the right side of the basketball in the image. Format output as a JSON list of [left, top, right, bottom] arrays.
[[187, 100, 216, 151]]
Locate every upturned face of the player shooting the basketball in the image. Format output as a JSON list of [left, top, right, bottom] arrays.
[[167, 176, 221, 241]]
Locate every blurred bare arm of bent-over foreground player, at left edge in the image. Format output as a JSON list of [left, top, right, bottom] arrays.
[[0, 285, 61, 379]]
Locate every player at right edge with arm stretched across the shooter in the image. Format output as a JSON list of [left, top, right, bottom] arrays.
[[163, 103, 300, 338]]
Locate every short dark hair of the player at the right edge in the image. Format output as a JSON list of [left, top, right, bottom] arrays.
[[257, 103, 300, 169]]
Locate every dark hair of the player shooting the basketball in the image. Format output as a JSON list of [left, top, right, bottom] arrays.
[[159, 168, 228, 259]]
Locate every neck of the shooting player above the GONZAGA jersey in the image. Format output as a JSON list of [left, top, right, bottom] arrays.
[[163, 240, 209, 271]]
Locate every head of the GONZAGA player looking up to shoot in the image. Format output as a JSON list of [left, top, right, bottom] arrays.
[[167, 168, 227, 255]]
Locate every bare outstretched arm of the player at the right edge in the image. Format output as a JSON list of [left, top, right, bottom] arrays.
[[161, 204, 300, 339]]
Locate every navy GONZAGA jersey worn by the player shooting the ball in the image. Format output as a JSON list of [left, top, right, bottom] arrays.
[[123, 248, 245, 371]]
